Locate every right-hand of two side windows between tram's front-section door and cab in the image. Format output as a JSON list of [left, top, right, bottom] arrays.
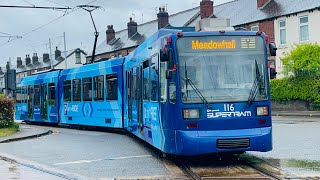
[[150, 55, 159, 101]]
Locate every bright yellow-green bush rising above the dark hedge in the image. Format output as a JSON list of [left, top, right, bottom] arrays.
[[281, 43, 320, 76]]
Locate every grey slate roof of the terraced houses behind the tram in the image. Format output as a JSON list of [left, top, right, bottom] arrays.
[[90, 0, 320, 55]]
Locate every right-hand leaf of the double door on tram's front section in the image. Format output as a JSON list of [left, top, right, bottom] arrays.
[[137, 66, 143, 132]]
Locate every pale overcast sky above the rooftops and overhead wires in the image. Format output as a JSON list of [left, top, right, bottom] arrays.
[[0, 0, 231, 67]]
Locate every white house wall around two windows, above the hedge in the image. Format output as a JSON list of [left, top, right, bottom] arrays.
[[274, 10, 320, 78]]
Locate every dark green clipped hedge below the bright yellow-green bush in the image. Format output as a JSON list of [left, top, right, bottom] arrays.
[[270, 76, 320, 108]]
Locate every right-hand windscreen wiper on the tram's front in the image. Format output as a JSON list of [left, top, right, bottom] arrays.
[[247, 60, 263, 107]]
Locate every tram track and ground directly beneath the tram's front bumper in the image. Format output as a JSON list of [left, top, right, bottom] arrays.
[[174, 153, 283, 180]]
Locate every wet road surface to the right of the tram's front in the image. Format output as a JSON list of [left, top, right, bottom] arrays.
[[250, 116, 320, 179]]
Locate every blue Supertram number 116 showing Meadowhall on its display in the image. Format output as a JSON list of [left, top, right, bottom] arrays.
[[16, 29, 276, 155]]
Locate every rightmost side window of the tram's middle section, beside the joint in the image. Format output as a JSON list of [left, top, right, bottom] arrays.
[[106, 74, 118, 100]]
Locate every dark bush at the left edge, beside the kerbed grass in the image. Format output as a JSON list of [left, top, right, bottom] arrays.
[[0, 98, 16, 128]]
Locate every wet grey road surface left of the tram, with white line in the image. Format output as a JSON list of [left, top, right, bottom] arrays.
[[0, 126, 171, 178]]
